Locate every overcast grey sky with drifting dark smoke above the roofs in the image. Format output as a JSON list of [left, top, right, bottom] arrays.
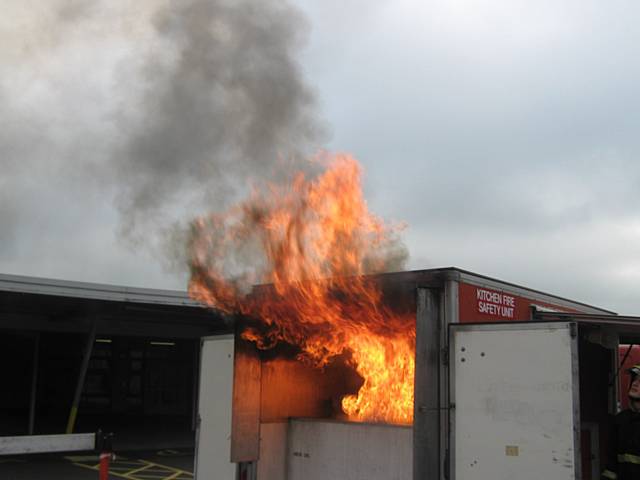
[[0, 0, 640, 314]]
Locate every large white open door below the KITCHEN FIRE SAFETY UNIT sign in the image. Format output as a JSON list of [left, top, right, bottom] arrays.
[[449, 322, 582, 480]]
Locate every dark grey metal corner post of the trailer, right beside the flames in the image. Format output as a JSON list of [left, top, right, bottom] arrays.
[[413, 287, 441, 480]]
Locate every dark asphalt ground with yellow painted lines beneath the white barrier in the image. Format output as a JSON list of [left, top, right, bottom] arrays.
[[0, 449, 194, 480]]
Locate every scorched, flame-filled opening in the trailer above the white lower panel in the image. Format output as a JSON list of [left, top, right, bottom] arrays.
[[236, 276, 416, 430]]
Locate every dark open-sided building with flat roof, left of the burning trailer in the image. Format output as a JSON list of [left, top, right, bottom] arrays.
[[0, 275, 228, 450]]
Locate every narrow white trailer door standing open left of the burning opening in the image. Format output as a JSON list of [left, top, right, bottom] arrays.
[[195, 335, 236, 480]]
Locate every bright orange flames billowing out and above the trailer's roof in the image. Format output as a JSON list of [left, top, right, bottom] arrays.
[[189, 155, 415, 424]]
